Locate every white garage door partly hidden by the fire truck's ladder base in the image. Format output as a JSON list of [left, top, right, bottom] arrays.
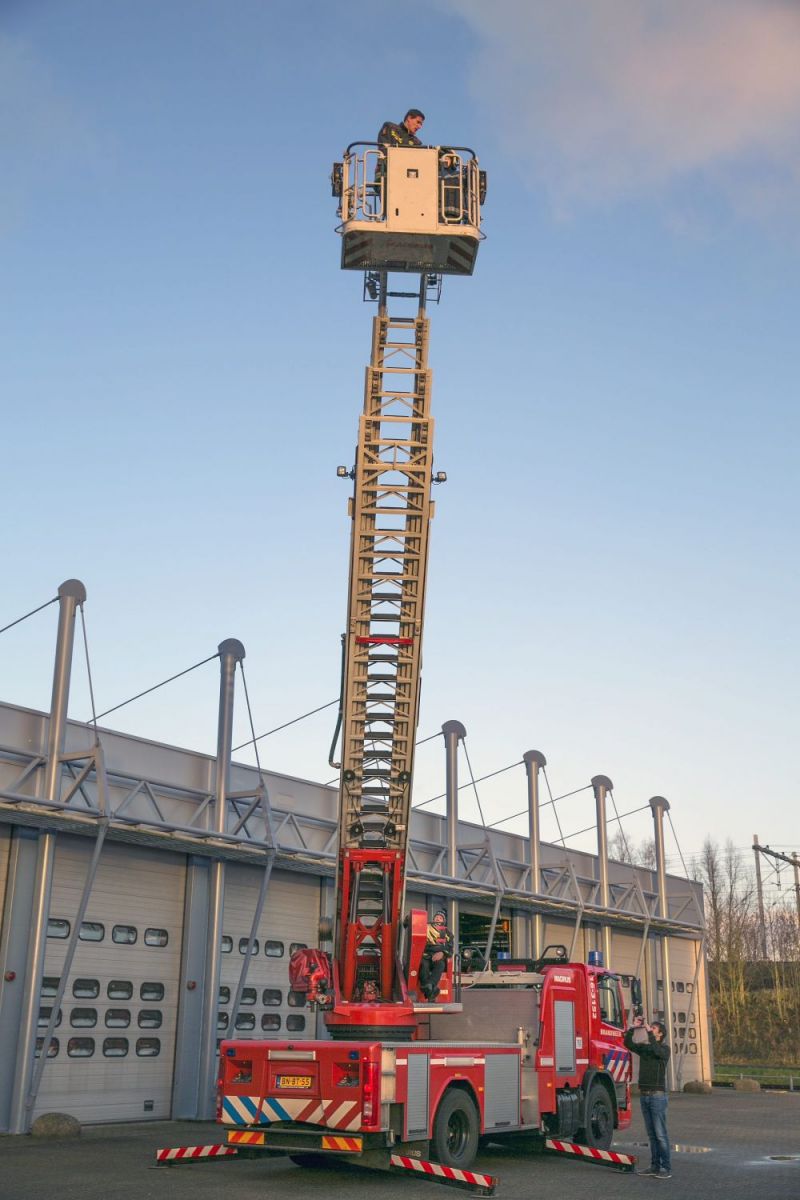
[[217, 863, 320, 1038]]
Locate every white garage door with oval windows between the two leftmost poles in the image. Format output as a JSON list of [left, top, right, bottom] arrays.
[[35, 835, 185, 1122]]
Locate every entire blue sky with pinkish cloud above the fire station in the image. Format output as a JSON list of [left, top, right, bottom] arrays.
[[0, 0, 800, 897]]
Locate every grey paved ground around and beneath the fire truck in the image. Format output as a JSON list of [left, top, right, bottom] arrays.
[[0, 1090, 800, 1200]]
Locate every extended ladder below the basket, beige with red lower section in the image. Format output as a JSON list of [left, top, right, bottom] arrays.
[[336, 272, 441, 1002]]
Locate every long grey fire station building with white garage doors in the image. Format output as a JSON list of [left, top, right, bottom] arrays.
[[0, 704, 711, 1133]]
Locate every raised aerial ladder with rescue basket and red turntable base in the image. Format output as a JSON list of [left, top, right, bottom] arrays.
[[311, 143, 486, 1038]]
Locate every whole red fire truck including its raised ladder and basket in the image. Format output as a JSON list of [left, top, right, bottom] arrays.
[[218, 143, 631, 1171]]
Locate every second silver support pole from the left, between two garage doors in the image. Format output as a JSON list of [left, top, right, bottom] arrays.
[[198, 637, 245, 1117]]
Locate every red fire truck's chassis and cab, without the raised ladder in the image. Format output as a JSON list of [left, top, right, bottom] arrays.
[[219, 947, 631, 1169]]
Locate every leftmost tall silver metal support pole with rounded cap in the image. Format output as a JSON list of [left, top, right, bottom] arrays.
[[8, 580, 86, 1133]]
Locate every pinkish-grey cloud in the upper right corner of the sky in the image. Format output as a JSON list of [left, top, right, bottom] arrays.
[[440, 0, 800, 211]]
